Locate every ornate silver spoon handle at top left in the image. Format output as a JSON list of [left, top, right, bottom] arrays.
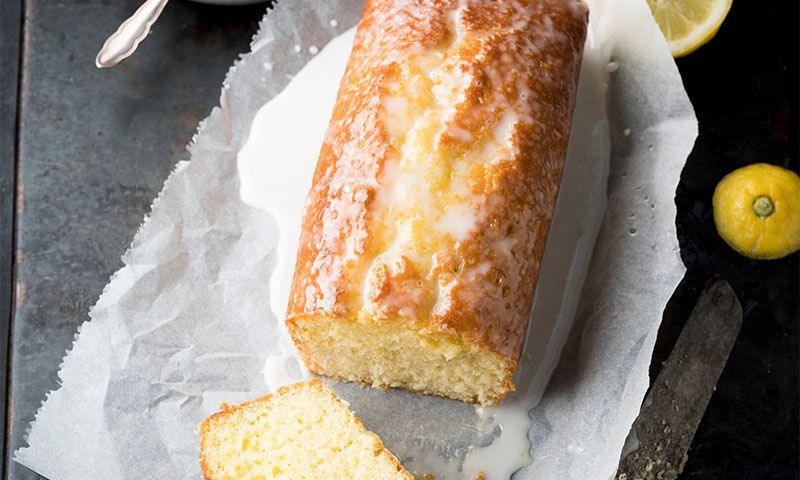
[[95, 0, 169, 68]]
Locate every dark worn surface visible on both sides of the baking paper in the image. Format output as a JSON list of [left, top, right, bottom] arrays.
[[0, 0, 800, 480]]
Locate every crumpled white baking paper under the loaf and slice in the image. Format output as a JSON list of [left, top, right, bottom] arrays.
[[14, 0, 697, 480]]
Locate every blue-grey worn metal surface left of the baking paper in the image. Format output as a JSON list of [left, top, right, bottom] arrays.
[[4, 0, 266, 479]]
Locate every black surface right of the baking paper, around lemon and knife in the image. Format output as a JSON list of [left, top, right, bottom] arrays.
[[653, 0, 800, 480]]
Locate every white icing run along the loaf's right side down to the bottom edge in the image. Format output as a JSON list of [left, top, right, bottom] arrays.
[[462, 25, 610, 480]]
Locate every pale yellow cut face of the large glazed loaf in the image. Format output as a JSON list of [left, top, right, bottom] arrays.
[[290, 318, 516, 405]]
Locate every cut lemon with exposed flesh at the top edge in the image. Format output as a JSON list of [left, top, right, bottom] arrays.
[[647, 0, 733, 57]]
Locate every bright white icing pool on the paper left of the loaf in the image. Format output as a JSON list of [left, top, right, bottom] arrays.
[[238, 28, 355, 324]]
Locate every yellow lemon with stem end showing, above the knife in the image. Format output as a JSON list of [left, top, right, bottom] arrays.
[[713, 163, 800, 260]]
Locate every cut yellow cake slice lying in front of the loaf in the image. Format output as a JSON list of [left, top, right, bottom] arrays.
[[200, 380, 413, 480]]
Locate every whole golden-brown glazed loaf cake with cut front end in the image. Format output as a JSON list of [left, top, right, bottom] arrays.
[[286, 0, 588, 404]]
